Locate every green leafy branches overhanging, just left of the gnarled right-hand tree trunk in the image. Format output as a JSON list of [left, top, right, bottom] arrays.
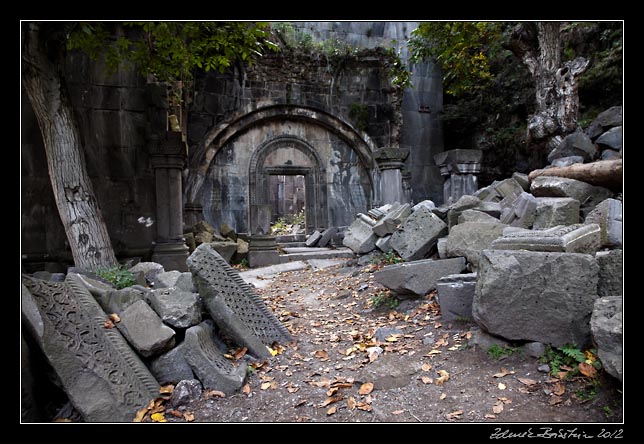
[[408, 22, 502, 96]]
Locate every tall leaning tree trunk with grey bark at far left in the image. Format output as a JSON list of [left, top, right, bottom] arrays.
[[22, 23, 117, 270]]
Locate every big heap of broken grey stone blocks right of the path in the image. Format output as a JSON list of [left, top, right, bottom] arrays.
[[344, 107, 623, 380]]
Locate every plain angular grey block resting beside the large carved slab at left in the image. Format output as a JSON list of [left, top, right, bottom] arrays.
[[116, 301, 174, 358]]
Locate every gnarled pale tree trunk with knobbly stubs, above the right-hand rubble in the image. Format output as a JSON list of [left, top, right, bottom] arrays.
[[510, 22, 589, 149]]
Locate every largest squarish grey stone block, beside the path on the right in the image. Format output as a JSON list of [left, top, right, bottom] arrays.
[[472, 250, 599, 348]]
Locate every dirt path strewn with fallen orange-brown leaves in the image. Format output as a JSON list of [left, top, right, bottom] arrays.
[[145, 263, 623, 430]]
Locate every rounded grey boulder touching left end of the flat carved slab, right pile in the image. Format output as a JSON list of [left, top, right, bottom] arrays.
[[445, 221, 507, 268]]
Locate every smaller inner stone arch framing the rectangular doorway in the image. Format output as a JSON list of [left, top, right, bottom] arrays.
[[249, 135, 327, 234]]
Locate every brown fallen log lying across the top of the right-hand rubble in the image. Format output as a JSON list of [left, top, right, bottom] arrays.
[[528, 159, 623, 188]]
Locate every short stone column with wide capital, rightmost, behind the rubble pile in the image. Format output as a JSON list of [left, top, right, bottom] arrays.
[[434, 149, 483, 205]]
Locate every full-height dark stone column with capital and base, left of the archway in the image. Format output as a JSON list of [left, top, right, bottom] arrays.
[[149, 132, 188, 271]]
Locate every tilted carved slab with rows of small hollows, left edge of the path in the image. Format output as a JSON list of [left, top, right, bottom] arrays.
[[186, 244, 292, 358]]
